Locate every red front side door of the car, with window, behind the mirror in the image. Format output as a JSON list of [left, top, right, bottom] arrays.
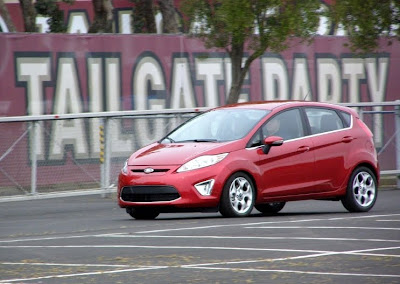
[[258, 108, 315, 200]]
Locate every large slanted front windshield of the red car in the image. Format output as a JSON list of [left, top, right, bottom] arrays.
[[162, 109, 269, 143]]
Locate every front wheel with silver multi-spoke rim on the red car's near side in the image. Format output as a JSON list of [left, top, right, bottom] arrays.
[[219, 172, 256, 217]]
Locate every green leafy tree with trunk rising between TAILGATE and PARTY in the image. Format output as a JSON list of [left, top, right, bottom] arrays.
[[181, 0, 320, 104]]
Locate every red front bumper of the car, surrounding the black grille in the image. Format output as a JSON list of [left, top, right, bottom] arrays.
[[118, 165, 229, 209]]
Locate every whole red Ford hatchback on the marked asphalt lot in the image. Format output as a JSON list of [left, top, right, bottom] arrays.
[[118, 101, 379, 219]]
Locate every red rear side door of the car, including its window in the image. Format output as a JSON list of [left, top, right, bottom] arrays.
[[304, 107, 355, 192]]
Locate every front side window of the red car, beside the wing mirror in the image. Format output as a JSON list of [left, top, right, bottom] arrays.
[[262, 109, 304, 140]]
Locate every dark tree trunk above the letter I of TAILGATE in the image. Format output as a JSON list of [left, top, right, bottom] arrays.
[[89, 0, 113, 33]]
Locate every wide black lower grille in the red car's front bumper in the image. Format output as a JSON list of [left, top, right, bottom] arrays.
[[121, 185, 180, 202]]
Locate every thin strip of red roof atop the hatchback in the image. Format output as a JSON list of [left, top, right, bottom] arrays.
[[219, 100, 351, 111]]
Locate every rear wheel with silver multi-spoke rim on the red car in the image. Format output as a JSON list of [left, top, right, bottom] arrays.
[[341, 167, 378, 212]]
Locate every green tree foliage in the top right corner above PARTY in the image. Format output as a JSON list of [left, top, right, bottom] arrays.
[[330, 0, 400, 52]]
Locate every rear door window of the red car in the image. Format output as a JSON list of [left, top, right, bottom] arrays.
[[305, 108, 345, 134]]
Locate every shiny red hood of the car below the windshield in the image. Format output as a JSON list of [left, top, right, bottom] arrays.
[[128, 142, 237, 166]]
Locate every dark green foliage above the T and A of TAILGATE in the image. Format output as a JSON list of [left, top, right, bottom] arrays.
[[35, 0, 74, 33]]
